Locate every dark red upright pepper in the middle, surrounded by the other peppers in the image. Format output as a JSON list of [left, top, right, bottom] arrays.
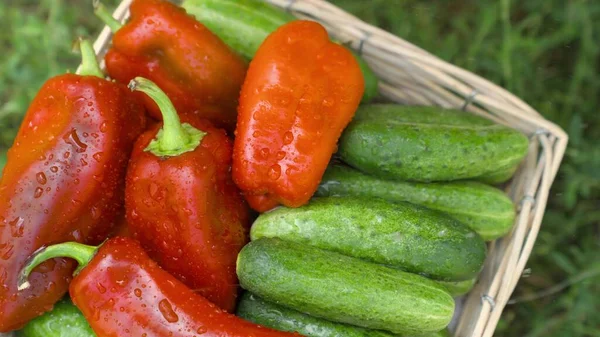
[[125, 79, 250, 311]]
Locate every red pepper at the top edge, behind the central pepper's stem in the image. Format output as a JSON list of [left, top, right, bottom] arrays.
[[97, 0, 247, 130]]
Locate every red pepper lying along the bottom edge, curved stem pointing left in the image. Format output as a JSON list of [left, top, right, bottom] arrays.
[[19, 237, 300, 337]]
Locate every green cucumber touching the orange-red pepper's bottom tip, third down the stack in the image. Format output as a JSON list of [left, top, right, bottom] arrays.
[[250, 197, 486, 281]]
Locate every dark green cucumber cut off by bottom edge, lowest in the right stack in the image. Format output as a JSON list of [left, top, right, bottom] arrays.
[[236, 292, 398, 337]]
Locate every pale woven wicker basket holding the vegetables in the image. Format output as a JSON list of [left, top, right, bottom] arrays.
[[0, 0, 568, 337]]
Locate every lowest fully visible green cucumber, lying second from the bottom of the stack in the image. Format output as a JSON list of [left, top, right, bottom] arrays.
[[237, 239, 454, 334]]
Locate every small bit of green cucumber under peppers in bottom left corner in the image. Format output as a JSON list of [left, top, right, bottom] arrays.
[[18, 300, 96, 337]]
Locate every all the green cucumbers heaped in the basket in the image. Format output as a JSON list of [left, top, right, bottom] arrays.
[[22, 0, 529, 337]]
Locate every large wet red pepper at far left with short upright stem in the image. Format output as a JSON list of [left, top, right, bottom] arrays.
[[0, 42, 145, 332]]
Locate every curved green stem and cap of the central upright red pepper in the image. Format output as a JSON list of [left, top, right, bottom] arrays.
[[129, 77, 206, 157]]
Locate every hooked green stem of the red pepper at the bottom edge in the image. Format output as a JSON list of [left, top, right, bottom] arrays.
[[17, 242, 98, 291]]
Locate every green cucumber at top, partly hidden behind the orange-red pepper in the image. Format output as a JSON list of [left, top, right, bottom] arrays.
[[182, 0, 378, 103]]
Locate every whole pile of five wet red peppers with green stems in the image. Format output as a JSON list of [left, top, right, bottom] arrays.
[[0, 0, 365, 337]]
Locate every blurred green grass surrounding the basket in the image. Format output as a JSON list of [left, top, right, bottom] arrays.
[[0, 0, 600, 337]]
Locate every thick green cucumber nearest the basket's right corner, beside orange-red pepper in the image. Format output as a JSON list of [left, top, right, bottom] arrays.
[[338, 104, 529, 182]]
